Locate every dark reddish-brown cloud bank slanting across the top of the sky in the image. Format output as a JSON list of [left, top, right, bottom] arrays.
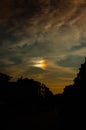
[[0, 0, 84, 44]]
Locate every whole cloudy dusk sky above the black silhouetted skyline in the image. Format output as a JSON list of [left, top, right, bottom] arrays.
[[0, 0, 86, 94]]
